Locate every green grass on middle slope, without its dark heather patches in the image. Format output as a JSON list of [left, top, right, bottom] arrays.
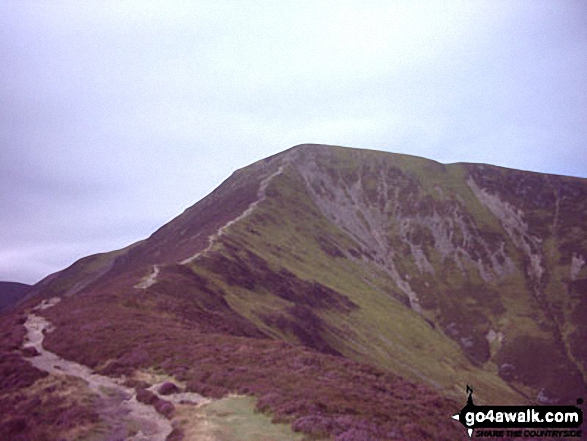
[[195, 166, 521, 404]]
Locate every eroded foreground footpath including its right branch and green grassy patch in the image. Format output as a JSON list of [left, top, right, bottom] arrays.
[[23, 297, 303, 441]]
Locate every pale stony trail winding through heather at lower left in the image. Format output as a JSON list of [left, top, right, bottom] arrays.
[[23, 298, 172, 441]]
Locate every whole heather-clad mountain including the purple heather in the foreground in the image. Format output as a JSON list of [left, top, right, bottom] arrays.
[[0, 145, 587, 440]]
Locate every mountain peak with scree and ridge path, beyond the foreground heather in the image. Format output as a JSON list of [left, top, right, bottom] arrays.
[[13, 145, 587, 410]]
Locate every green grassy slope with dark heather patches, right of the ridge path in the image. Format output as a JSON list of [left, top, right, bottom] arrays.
[[185, 158, 522, 403]]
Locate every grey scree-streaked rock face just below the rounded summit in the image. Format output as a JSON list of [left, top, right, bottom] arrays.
[[292, 150, 515, 312]]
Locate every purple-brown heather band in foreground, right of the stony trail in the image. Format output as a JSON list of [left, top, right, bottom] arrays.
[[36, 290, 463, 440]]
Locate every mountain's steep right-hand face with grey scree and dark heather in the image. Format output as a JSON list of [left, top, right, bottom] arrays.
[[298, 149, 587, 402]]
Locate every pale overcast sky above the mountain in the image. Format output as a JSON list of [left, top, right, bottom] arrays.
[[0, 0, 587, 283]]
